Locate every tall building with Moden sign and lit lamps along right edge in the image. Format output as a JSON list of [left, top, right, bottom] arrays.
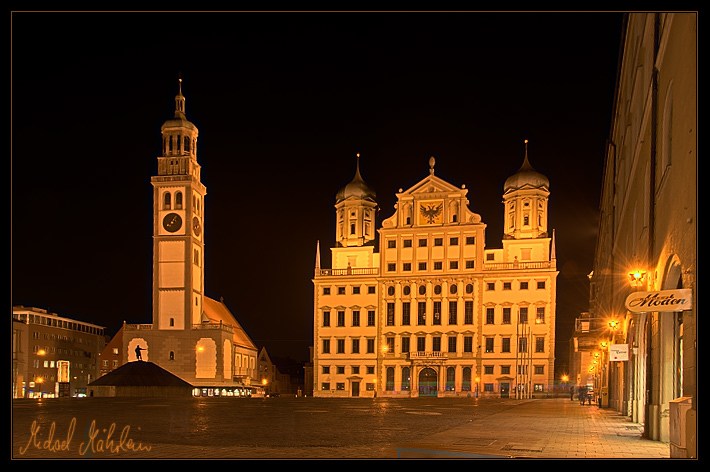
[[583, 12, 698, 457]]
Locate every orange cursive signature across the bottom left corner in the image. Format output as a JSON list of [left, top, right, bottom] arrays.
[[20, 418, 151, 456]]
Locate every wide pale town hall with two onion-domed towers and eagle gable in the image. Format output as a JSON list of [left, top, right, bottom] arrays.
[[313, 145, 558, 398]]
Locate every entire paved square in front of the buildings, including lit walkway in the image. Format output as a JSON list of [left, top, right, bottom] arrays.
[[12, 398, 670, 459]]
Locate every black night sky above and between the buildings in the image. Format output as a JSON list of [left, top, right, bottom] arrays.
[[11, 13, 622, 370]]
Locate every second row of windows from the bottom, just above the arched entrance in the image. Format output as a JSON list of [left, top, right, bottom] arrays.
[[321, 336, 545, 354]]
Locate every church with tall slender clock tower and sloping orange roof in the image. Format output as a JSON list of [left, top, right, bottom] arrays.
[[122, 82, 258, 396]]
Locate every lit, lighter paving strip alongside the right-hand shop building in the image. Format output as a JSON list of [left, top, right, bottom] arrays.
[[398, 398, 670, 459]]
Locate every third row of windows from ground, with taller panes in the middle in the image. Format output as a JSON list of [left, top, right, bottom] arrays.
[[322, 300, 545, 327]]
